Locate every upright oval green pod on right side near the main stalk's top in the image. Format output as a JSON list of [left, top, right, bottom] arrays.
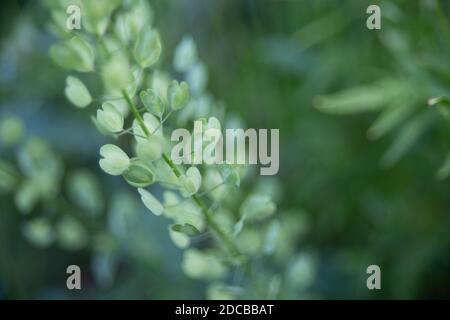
[[134, 29, 161, 68]]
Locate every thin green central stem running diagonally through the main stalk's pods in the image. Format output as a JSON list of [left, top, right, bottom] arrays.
[[122, 90, 240, 257]]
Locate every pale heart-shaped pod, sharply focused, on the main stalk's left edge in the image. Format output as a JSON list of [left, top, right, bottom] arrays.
[[99, 144, 130, 176]]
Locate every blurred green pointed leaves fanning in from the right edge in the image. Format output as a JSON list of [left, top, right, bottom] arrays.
[[315, 0, 450, 179]]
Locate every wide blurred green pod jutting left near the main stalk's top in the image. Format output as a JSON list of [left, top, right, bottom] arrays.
[[50, 36, 95, 72]]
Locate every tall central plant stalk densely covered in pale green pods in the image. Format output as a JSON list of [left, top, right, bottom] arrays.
[[43, 0, 314, 298]]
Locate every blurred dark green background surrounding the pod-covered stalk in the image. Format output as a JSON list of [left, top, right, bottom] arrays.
[[0, 0, 450, 299]]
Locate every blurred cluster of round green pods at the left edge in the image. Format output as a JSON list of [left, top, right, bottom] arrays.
[[0, 116, 95, 250]]
